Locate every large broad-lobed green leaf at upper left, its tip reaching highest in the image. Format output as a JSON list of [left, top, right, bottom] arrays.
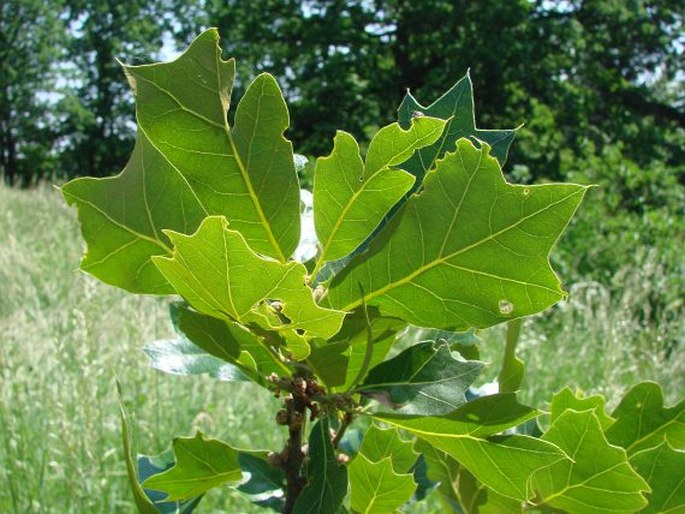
[[62, 29, 300, 294]]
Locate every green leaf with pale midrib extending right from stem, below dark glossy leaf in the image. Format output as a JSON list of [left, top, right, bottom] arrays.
[[374, 393, 566, 501]]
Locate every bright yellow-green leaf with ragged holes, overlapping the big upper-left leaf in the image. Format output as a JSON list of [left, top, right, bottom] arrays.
[[153, 216, 345, 360]]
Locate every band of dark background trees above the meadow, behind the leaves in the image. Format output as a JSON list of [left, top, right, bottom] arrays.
[[0, 0, 685, 183]]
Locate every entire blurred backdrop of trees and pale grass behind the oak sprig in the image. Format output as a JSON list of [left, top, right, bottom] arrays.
[[0, 0, 685, 513]]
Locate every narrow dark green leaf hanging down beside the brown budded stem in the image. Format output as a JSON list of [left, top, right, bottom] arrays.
[[293, 418, 348, 514]]
